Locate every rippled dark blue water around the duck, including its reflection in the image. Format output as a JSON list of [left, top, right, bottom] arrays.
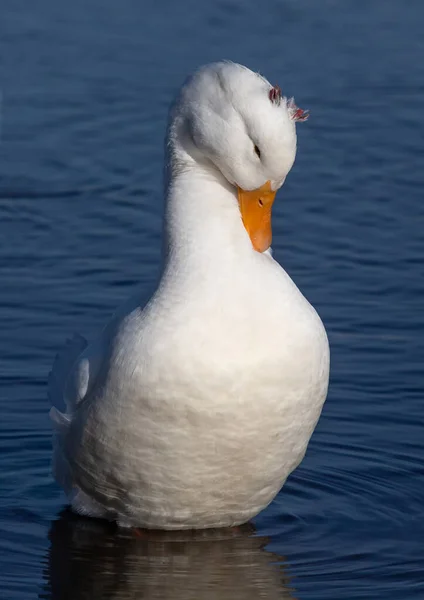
[[0, 0, 424, 600]]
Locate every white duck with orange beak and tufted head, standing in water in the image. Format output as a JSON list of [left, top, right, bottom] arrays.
[[50, 62, 329, 529]]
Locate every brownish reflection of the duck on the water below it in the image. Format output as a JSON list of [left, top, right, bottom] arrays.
[[40, 512, 294, 600]]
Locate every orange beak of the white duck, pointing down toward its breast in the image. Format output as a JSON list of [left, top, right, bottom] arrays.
[[238, 181, 275, 252]]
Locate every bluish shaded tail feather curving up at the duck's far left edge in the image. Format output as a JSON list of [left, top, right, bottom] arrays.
[[48, 334, 87, 412]]
